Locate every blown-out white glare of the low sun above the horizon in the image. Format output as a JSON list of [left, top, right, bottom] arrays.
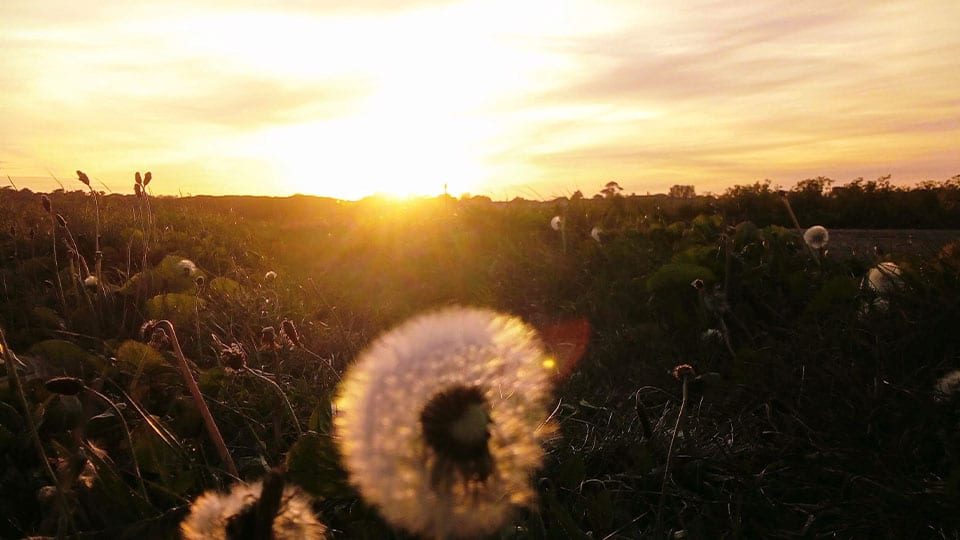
[[217, 5, 552, 200]]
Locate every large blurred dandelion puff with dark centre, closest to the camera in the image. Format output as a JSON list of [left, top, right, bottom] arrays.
[[334, 307, 552, 538]]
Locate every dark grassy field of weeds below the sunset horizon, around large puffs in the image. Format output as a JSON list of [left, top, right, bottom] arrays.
[[0, 177, 960, 539]]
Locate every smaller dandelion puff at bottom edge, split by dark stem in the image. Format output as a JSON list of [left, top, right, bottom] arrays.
[[180, 482, 326, 540]]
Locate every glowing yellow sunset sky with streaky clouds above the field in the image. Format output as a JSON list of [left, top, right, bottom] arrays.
[[0, 0, 960, 200]]
